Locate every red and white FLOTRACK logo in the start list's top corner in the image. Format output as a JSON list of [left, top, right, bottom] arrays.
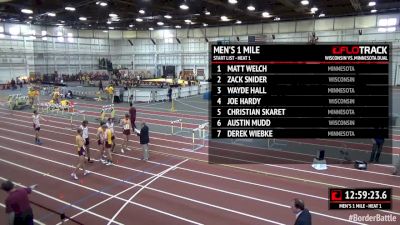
[[332, 45, 388, 55]]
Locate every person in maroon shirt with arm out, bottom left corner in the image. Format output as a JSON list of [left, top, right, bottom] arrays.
[[1, 180, 36, 225]]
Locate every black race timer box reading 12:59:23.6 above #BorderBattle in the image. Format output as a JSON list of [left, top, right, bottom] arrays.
[[329, 188, 392, 209]]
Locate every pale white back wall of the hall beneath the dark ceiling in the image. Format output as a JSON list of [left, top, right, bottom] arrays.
[[0, 14, 400, 84]]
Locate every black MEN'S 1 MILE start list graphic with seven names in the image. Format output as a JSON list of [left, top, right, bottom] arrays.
[[210, 43, 390, 139]]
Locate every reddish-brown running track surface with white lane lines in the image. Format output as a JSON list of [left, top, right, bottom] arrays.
[[0, 107, 400, 225]]
